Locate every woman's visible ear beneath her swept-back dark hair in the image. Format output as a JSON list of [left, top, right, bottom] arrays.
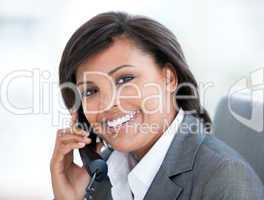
[[162, 63, 178, 93]]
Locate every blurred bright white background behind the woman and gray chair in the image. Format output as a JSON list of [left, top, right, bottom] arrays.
[[0, 0, 264, 200]]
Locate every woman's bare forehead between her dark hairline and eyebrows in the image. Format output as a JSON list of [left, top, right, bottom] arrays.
[[76, 38, 154, 79]]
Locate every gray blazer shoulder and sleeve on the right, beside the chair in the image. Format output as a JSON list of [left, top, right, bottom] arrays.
[[194, 135, 264, 200]]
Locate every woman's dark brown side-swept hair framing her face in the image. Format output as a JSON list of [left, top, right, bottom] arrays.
[[59, 12, 212, 128]]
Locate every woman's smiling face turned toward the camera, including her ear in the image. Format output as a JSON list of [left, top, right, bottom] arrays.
[[76, 38, 177, 156]]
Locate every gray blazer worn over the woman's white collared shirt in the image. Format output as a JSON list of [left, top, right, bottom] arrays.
[[94, 114, 264, 200]]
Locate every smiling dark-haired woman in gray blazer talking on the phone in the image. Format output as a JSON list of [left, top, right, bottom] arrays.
[[50, 12, 264, 200]]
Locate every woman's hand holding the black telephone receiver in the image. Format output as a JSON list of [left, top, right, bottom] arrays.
[[50, 113, 91, 200]]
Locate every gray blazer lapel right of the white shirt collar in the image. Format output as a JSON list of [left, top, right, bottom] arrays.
[[144, 114, 204, 200]]
